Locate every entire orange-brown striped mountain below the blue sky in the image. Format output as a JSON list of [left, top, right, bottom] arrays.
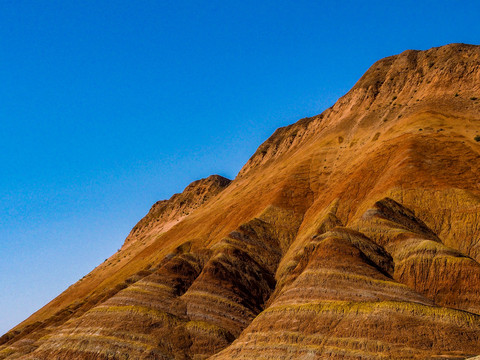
[[0, 44, 480, 359]]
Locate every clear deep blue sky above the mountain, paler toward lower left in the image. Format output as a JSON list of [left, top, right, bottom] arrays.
[[0, 0, 480, 334]]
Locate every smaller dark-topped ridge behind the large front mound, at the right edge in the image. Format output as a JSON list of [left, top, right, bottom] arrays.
[[357, 199, 480, 314]]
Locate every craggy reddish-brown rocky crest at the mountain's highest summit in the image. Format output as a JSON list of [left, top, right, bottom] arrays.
[[239, 44, 480, 176]]
